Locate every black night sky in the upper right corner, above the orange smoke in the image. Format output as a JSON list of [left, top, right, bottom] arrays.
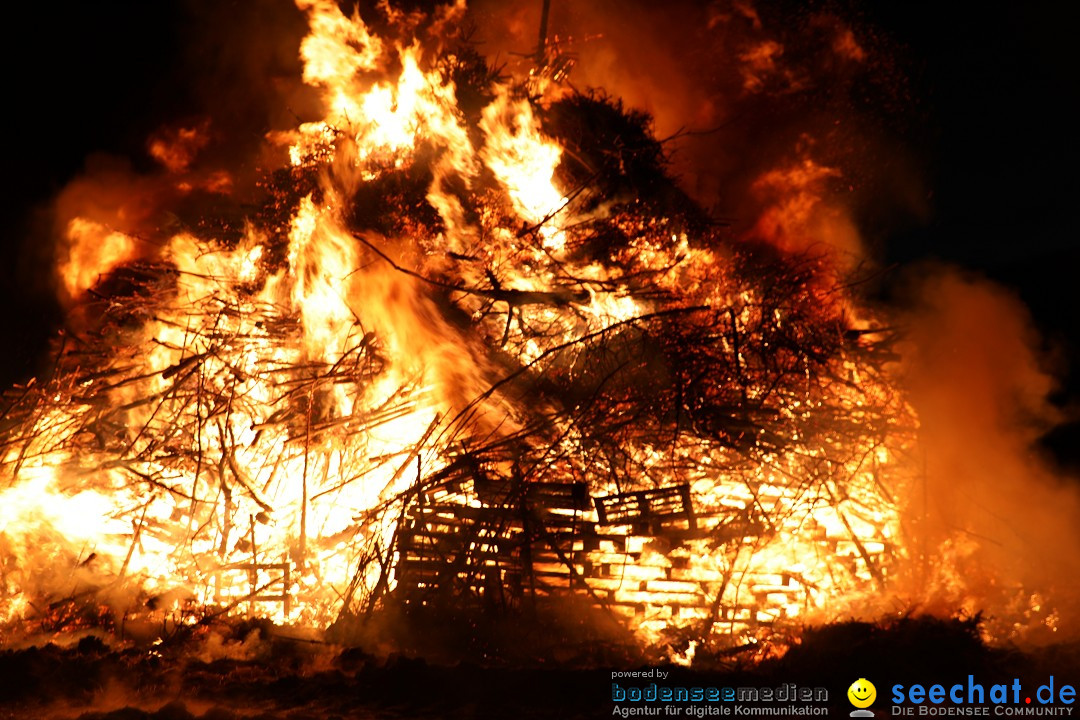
[[869, 2, 1080, 466]]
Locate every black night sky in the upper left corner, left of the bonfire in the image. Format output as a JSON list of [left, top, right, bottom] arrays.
[[0, 2, 203, 385]]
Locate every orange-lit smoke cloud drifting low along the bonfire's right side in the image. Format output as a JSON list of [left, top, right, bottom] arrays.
[[903, 267, 1080, 642]]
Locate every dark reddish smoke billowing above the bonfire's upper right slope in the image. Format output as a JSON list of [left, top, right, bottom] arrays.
[[471, 0, 927, 271]]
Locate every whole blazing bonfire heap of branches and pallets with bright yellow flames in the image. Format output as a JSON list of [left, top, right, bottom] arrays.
[[0, 0, 1062, 662]]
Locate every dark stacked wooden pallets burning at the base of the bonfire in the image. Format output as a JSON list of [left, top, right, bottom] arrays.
[[397, 483, 721, 613]]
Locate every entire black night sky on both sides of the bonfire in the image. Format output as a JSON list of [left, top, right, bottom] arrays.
[[0, 0, 1080, 455]]
